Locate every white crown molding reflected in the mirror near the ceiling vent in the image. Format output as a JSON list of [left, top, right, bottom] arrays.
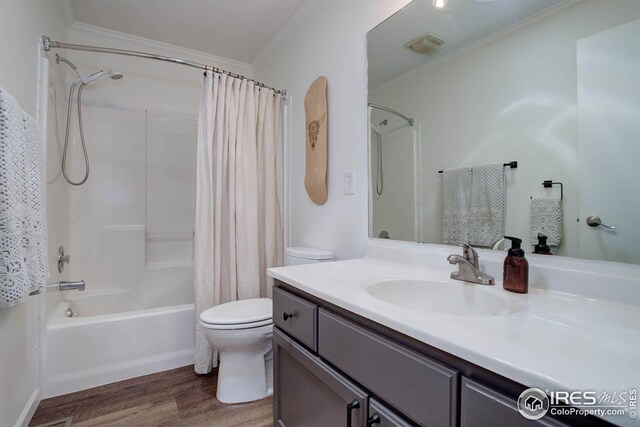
[[369, 0, 593, 92]]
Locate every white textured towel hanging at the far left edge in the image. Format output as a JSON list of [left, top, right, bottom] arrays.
[[0, 88, 49, 307]]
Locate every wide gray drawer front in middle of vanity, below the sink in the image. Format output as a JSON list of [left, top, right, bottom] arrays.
[[318, 309, 458, 427]]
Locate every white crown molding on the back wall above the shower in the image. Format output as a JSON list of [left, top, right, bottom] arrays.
[[67, 21, 253, 78]]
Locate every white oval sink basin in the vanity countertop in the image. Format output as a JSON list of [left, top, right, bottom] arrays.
[[366, 279, 511, 316]]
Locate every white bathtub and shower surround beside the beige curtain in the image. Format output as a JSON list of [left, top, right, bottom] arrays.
[[42, 101, 196, 397]]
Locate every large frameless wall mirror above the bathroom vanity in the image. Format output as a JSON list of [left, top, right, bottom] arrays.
[[367, 0, 640, 264]]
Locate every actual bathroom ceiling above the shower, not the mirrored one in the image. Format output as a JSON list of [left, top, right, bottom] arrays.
[[71, 0, 305, 63]]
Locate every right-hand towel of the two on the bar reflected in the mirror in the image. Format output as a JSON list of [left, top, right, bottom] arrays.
[[468, 163, 506, 246]]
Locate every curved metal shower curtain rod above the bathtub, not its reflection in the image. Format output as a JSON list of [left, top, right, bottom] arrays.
[[42, 36, 287, 97]]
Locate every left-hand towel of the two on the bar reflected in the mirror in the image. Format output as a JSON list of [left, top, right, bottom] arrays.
[[442, 168, 472, 244]]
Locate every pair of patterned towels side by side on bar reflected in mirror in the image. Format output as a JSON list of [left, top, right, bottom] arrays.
[[442, 163, 506, 246]]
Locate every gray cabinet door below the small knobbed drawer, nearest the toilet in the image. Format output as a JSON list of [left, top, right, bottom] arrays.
[[273, 328, 368, 427]]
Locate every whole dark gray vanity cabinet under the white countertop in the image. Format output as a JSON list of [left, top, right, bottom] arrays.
[[273, 282, 592, 427]]
